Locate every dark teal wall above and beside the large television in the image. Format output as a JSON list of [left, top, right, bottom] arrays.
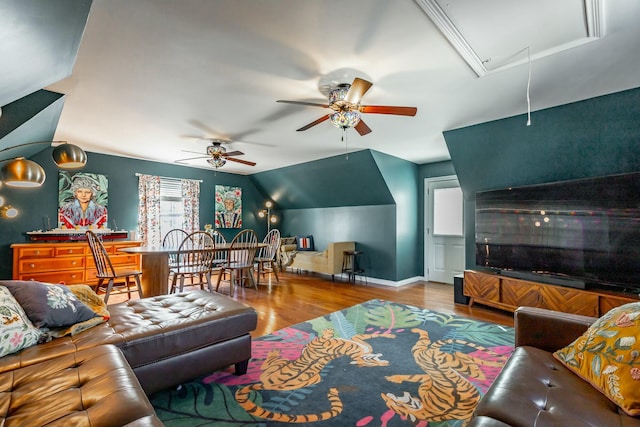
[[444, 88, 640, 268]]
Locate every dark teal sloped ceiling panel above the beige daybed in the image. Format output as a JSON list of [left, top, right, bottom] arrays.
[[250, 150, 395, 209]]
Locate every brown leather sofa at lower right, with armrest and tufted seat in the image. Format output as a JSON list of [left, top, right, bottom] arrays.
[[468, 307, 640, 427]]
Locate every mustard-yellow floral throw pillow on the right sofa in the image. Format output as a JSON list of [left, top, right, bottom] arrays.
[[553, 302, 640, 416]]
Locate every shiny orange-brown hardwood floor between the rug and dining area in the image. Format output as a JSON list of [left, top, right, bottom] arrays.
[[109, 272, 513, 337]]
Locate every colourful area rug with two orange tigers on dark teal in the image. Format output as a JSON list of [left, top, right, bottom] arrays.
[[151, 299, 514, 427]]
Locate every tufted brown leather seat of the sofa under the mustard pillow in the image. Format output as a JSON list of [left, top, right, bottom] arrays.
[[470, 346, 640, 427]]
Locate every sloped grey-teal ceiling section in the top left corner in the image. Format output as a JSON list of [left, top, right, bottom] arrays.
[[0, 0, 92, 161]]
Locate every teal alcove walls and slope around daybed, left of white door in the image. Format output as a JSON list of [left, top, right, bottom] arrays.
[[252, 150, 421, 281]]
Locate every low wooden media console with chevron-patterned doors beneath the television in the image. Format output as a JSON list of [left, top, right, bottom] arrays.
[[463, 270, 639, 317]]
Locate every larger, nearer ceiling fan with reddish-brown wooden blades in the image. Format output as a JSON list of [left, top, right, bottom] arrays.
[[276, 77, 418, 135]]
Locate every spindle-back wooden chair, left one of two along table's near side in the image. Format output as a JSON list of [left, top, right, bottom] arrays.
[[169, 231, 219, 293]]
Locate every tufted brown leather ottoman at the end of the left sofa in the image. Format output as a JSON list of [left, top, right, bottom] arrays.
[[104, 290, 257, 394]]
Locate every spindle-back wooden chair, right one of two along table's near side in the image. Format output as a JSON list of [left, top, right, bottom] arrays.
[[216, 229, 258, 294]]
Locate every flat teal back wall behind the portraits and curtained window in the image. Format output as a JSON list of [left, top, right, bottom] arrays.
[[0, 148, 267, 279]]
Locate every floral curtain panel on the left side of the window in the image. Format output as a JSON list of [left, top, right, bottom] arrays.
[[138, 174, 162, 246]]
